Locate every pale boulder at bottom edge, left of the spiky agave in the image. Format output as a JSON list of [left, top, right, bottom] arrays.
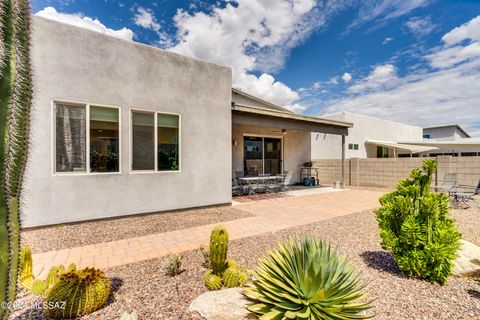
[[189, 288, 250, 320]]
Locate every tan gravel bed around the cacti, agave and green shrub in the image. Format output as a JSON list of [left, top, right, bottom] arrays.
[[14, 209, 480, 320]]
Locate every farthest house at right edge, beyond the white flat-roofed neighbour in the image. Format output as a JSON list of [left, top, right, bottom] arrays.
[[402, 124, 480, 157]]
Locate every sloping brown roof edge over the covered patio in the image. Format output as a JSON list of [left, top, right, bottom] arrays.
[[232, 103, 353, 135]]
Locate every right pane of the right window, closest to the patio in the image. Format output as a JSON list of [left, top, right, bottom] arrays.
[[157, 113, 179, 171]]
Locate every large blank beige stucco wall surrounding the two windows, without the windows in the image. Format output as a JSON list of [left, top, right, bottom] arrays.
[[22, 17, 232, 227]]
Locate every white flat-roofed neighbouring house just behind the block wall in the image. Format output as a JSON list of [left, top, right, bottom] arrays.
[[312, 112, 436, 159]]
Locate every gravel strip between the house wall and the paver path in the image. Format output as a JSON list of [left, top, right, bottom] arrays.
[[22, 206, 253, 253]]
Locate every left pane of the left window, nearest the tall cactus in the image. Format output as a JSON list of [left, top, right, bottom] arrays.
[[55, 104, 87, 172]]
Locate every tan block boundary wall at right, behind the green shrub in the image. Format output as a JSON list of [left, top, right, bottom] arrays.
[[313, 156, 480, 188]]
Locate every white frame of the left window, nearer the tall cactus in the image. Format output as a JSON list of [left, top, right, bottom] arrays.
[[51, 99, 122, 176]]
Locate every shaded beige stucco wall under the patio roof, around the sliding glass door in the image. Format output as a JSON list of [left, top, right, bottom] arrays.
[[232, 125, 310, 183]]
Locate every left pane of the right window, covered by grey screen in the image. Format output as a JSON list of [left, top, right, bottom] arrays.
[[132, 112, 155, 170]]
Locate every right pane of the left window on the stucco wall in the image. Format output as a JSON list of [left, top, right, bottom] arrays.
[[90, 106, 119, 172]]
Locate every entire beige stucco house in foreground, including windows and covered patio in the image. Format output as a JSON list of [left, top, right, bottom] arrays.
[[22, 17, 352, 227]]
